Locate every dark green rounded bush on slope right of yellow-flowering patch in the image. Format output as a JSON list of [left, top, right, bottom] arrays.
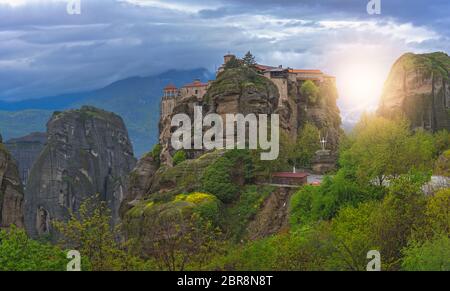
[[202, 150, 253, 203]]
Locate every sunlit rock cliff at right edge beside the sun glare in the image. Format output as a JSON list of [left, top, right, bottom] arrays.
[[378, 52, 450, 131]]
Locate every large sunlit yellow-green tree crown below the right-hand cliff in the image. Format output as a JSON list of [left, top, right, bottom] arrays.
[[339, 115, 434, 185]]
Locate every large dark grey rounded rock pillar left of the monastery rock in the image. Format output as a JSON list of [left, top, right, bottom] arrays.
[[25, 106, 136, 236]]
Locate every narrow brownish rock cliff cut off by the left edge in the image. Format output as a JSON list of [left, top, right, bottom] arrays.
[[0, 135, 24, 228]]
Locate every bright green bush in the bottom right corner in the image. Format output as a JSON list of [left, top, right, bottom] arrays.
[[402, 234, 450, 271]]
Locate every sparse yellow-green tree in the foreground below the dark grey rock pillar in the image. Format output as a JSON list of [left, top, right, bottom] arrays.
[[53, 195, 144, 271]]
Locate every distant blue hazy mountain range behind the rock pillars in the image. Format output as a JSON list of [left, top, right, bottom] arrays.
[[0, 68, 215, 156]]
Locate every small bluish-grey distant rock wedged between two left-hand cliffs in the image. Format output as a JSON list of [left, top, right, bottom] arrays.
[[5, 132, 47, 185]]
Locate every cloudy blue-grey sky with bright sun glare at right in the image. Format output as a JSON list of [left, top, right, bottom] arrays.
[[0, 0, 450, 122]]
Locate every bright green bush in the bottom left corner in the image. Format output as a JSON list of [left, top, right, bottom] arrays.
[[0, 226, 68, 271]]
